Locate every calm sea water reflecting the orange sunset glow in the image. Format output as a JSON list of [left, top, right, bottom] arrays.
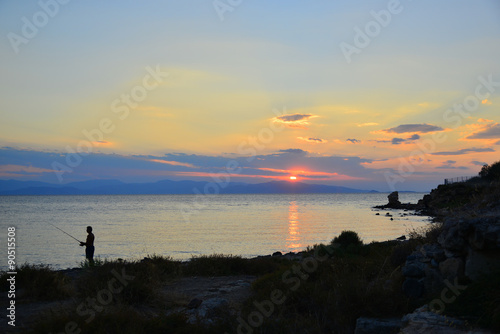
[[0, 193, 428, 269]]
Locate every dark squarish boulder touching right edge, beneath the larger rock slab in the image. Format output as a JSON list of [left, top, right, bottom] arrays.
[[465, 248, 500, 280]]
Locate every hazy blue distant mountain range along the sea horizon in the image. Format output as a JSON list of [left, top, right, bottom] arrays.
[[0, 180, 377, 195]]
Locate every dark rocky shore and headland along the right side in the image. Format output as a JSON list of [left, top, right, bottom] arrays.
[[364, 180, 500, 334]]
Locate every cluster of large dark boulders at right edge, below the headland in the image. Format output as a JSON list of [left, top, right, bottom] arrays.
[[402, 217, 500, 298]]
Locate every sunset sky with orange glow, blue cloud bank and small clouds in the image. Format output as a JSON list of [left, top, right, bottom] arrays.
[[0, 0, 500, 191]]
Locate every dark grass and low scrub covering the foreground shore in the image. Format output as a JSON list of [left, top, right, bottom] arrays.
[[1, 228, 500, 333]]
